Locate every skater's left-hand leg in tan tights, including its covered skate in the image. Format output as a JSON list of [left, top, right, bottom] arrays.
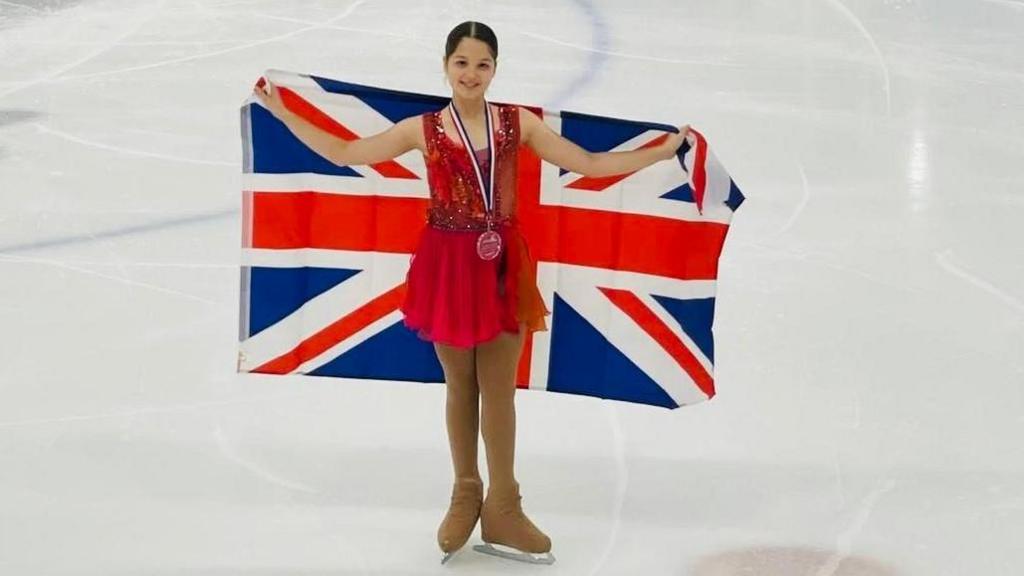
[[434, 344, 483, 564]]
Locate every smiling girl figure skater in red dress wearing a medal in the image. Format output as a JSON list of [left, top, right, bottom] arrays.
[[255, 22, 688, 564]]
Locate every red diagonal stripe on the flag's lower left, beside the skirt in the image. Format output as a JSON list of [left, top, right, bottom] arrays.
[[253, 283, 406, 374]]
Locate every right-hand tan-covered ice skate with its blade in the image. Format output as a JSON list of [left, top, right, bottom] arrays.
[[473, 483, 555, 564]]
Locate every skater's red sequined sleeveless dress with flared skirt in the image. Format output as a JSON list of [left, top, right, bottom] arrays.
[[401, 106, 550, 347]]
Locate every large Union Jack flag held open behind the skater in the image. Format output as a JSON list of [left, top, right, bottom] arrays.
[[238, 71, 743, 408]]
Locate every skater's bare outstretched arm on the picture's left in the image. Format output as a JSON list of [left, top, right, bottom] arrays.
[[254, 82, 422, 166]]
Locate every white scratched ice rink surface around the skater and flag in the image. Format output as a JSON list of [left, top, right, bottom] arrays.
[[0, 0, 1024, 576]]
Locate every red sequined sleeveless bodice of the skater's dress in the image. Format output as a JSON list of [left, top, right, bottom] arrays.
[[423, 106, 519, 230]]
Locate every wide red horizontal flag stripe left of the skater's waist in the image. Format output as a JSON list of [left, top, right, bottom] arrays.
[[252, 192, 427, 253]]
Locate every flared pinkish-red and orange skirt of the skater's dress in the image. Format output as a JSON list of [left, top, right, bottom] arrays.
[[401, 220, 551, 347]]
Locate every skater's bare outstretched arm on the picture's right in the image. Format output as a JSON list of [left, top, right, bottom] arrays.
[[519, 109, 689, 176]]
